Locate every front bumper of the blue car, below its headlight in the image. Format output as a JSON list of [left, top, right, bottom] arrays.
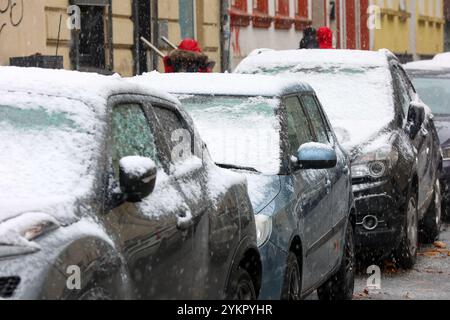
[[255, 240, 287, 300]]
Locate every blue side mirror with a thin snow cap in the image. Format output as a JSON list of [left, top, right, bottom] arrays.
[[294, 142, 337, 170]]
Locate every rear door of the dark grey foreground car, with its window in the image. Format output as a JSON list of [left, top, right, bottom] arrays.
[[149, 104, 214, 299]]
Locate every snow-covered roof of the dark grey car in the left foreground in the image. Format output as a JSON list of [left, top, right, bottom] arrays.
[[0, 67, 179, 106]]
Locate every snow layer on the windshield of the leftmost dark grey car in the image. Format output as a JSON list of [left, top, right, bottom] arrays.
[[0, 93, 99, 220]]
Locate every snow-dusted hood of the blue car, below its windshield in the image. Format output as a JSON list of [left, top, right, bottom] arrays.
[[239, 173, 281, 214]]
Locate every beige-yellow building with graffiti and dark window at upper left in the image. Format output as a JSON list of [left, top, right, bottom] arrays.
[[0, 0, 220, 76]]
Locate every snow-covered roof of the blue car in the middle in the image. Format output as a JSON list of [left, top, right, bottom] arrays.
[[130, 72, 314, 97]]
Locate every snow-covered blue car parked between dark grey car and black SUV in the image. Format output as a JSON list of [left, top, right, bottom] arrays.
[[133, 72, 355, 299]]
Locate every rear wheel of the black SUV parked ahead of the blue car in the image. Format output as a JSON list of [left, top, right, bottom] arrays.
[[421, 179, 442, 243]]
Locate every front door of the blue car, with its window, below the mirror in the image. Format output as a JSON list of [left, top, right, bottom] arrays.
[[284, 96, 331, 290]]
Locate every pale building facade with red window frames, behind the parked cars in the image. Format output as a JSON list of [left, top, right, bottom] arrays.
[[224, 0, 329, 69]]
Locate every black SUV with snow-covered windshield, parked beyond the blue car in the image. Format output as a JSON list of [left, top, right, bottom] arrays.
[[236, 50, 442, 268]]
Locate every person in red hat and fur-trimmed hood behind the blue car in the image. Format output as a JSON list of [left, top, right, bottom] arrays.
[[164, 38, 215, 73]]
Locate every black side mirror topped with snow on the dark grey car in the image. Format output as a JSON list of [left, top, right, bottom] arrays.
[[119, 156, 157, 203]]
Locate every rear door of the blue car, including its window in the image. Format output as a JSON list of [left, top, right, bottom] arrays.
[[301, 94, 351, 271]]
